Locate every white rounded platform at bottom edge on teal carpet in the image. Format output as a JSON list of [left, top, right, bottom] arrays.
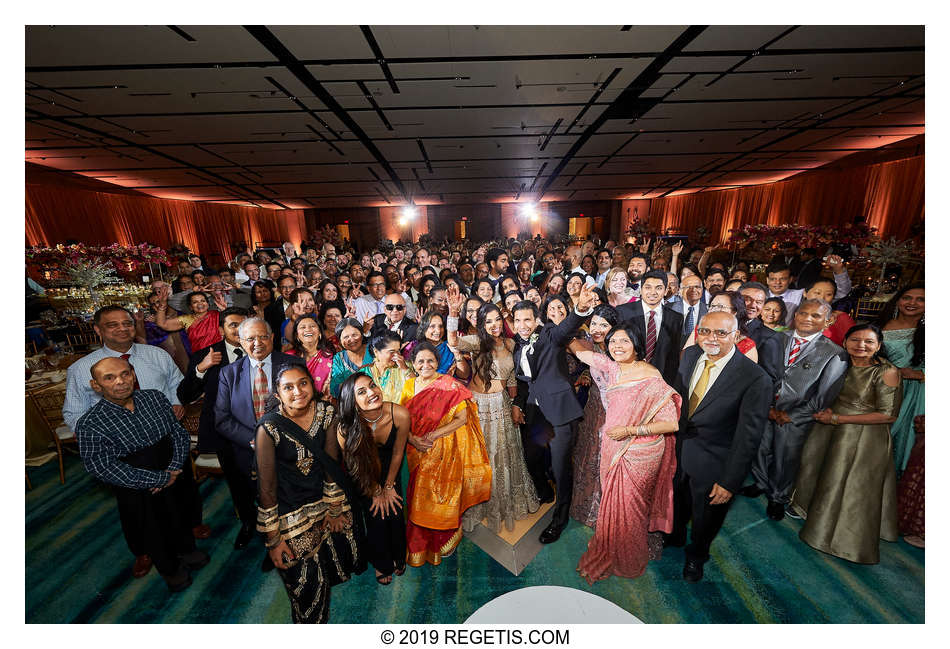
[[465, 586, 643, 624]]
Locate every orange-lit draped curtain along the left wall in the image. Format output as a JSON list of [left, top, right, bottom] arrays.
[[26, 184, 306, 261]]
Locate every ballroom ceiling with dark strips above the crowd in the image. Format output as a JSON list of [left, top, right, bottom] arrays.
[[25, 25, 924, 209]]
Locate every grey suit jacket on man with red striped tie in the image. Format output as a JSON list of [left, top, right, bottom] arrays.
[[775, 335, 848, 427]]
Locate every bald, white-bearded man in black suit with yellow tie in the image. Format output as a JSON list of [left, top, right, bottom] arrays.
[[666, 311, 772, 582]]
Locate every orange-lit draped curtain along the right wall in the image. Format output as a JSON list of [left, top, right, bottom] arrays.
[[650, 156, 924, 241]]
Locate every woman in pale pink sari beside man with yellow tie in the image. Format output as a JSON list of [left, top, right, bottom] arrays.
[[570, 326, 681, 584]]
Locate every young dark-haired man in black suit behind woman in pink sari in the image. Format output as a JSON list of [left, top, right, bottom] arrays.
[[617, 270, 683, 386]]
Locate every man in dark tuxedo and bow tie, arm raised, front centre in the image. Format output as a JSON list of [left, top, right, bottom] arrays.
[[512, 285, 594, 543]]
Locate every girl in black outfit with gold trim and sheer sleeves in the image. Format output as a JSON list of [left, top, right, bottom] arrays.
[[255, 365, 366, 624]]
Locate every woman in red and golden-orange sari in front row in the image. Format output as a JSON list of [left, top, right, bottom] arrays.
[[400, 341, 491, 567]]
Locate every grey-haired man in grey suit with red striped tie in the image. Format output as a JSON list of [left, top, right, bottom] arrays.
[[741, 299, 848, 521]]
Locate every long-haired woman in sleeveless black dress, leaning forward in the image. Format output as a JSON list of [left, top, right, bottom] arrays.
[[337, 373, 409, 586]]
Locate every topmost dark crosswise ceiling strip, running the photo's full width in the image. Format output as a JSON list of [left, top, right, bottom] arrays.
[[26, 45, 924, 74]]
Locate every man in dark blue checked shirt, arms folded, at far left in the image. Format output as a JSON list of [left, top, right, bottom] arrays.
[[76, 357, 209, 592]]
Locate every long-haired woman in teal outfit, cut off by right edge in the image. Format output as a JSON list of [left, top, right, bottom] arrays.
[[881, 283, 924, 474]]
